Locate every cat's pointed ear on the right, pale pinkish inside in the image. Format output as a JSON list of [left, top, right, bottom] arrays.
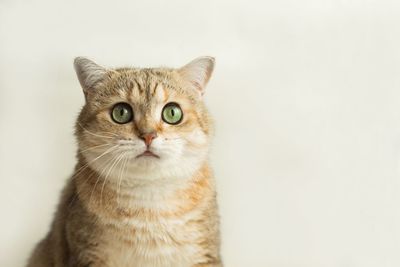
[[178, 57, 215, 95]]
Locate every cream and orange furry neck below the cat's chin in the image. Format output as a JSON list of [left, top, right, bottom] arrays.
[[74, 158, 214, 217]]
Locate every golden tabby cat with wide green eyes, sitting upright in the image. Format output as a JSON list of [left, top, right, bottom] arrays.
[[27, 57, 222, 267]]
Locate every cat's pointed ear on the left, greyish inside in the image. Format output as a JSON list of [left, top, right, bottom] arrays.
[[74, 57, 107, 95]]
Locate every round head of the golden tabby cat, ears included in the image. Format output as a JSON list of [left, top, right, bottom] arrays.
[[74, 57, 214, 183]]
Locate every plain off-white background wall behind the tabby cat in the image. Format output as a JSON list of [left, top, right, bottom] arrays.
[[0, 0, 400, 267]]
